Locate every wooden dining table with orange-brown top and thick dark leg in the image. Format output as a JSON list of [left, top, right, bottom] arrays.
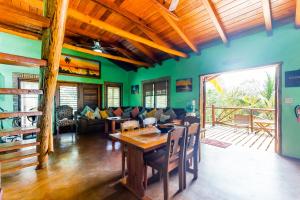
[[110, 127, 167, 199]]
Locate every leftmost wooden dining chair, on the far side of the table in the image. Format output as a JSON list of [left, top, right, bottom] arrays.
[[121, 120, 140, 177]]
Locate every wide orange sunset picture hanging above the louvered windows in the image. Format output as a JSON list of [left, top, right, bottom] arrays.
[[59, 54, 101, 79]]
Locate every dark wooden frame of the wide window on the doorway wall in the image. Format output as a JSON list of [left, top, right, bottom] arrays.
[[141, 76, 171, 109]]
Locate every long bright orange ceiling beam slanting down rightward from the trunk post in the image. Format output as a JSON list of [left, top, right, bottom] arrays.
[[68, 9, 187, 57]]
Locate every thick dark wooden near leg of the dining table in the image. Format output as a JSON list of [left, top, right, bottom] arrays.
[[125, 145, 147, 199]]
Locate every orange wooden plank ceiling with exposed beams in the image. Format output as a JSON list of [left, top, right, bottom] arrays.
[[0, 0, 300, 70]]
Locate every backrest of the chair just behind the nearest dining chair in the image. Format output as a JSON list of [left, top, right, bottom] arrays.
[[186, 123, 200, 152]]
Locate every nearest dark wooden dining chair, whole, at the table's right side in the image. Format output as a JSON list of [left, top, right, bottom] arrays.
[[144, 127, 186, 200]]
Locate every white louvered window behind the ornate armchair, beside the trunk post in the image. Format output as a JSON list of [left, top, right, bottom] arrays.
[[59, 84, 78, 112]]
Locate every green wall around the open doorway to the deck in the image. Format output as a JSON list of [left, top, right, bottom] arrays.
[[129, 24, 300, 158]]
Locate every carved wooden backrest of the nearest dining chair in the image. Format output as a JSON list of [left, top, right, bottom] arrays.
[[165, 126, 186, 166]]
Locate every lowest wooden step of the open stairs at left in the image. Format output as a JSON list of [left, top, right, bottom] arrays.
[[1, 159, 39, 175]]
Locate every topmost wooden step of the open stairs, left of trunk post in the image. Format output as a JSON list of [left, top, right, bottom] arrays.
[[0, 53, 47, 67]]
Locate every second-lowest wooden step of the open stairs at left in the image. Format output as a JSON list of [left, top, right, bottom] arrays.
[[0, 149, 39, 164]]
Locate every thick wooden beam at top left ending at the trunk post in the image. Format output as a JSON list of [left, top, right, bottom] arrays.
[[0, 4, 50, 28]]
